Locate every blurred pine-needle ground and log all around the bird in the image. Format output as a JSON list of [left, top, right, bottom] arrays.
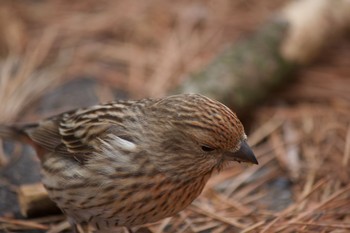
[[0, 0, 350, 233]]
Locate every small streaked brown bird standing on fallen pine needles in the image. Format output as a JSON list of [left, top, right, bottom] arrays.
[[0, 94, 258, 231]]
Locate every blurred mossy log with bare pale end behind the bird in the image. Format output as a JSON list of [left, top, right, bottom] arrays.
[[176, 0, 350, 114]]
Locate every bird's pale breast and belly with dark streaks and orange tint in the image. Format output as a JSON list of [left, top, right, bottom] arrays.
[[43, 153, 210, 229]]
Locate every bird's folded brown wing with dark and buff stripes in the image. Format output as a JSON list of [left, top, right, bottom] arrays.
[[26, 105, 131, 162]]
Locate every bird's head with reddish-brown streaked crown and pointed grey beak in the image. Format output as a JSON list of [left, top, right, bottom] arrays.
[[142, 94, 258, 175]]
